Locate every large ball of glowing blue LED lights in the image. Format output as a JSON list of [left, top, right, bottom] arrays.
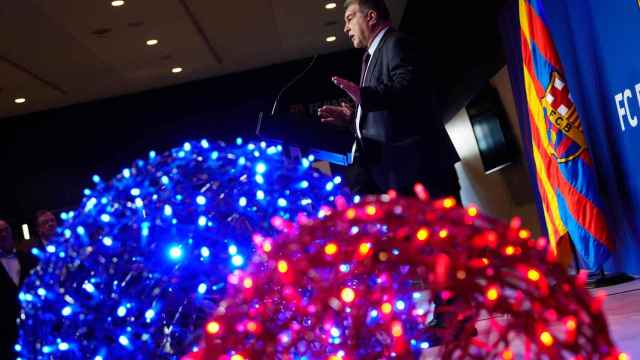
[[16, 139, 349, 360]]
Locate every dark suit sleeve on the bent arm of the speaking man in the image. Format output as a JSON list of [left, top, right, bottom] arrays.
[[360, 36, 419, 112]]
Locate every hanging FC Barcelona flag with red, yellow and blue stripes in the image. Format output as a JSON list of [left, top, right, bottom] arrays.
[[519, 0, 612, 270]]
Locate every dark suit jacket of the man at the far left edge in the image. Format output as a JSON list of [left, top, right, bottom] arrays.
[[0, 251, 37, 359]]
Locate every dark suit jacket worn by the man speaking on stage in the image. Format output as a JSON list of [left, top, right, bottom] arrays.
[[358, 28, 460, 191]]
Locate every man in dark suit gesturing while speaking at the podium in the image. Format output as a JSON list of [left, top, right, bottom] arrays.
[[319, 0, 460, 198]]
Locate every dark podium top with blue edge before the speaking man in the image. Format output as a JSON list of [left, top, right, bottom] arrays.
[[256, 112, 354, 166]]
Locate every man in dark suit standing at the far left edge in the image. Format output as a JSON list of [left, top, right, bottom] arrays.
[[0, 220, 37, 359]]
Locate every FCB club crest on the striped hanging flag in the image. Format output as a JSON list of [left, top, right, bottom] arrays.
[[540, 71, 586, 163]]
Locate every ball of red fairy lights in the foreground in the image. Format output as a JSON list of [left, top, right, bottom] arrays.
[[185, 187, 629, 360]]
